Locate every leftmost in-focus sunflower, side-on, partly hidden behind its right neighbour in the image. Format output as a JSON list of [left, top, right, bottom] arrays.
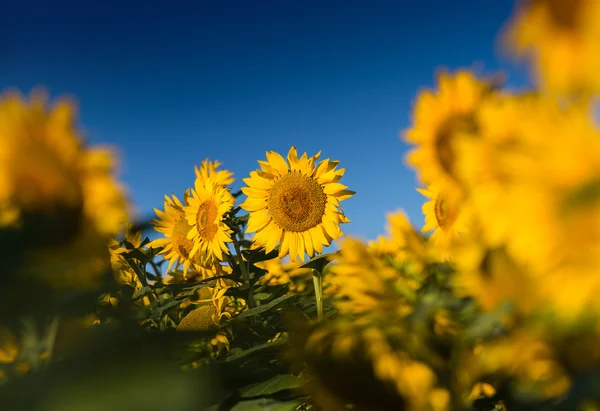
[[148, 192, 200, 278]]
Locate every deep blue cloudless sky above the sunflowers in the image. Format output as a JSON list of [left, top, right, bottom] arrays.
[[0, 0, 526, 243]]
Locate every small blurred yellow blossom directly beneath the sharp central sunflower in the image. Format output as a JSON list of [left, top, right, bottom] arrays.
[[256, 258, 312, 294]]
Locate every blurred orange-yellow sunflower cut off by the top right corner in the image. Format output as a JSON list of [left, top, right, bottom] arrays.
[[504, 0, 600, 93]]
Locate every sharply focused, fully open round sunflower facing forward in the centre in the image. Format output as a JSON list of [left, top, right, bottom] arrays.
[[241, 147, 354, 261]]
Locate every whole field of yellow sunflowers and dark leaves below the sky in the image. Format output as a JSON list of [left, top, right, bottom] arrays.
[[0, 0, 600, 411]]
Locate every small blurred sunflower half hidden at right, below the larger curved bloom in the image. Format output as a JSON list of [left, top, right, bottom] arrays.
[[417, 185, 468, 258]]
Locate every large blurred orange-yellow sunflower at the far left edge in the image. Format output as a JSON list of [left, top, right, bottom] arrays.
[[0, 92, 127, 238]]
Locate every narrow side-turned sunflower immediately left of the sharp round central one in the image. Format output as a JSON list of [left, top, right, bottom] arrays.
[[183, 178, 235, 264]]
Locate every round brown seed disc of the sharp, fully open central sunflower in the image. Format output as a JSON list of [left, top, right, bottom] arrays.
[[268, 173, 327, 232]]
